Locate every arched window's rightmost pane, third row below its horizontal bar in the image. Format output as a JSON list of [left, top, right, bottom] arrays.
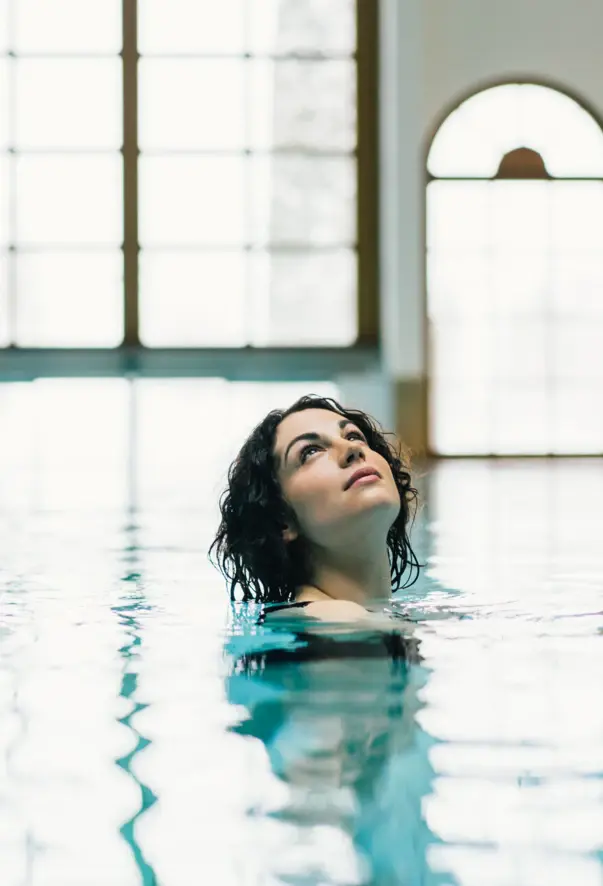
[[551, 315, 603, 380]]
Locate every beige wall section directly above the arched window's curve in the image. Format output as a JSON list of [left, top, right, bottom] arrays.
[[423, 0, 603, 135]]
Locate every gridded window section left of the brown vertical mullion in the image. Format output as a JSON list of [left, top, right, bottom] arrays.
[[0, 0, 123, 347]]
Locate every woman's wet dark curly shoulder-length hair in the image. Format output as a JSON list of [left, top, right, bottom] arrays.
[[209, 394, 420, 603]]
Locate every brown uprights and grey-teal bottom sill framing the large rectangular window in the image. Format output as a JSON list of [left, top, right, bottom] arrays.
[[0, 0, 379, 379]]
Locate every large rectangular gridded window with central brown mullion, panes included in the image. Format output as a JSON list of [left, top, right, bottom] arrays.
[[0, 0, 376, 348]]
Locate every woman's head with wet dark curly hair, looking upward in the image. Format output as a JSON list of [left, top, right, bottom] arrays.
[[210, 395, 418, 602]]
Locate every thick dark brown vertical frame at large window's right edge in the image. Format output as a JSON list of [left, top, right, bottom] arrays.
[[356, 0, 379, 345]]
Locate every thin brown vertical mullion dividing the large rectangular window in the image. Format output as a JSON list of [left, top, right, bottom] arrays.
[[121, 0, 140, 346]]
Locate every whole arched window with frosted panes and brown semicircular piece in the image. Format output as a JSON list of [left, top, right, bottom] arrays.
[[427, 84, 603, 455]]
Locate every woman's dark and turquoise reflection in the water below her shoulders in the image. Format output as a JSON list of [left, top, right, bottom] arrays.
[[227, 620, 441, 886]]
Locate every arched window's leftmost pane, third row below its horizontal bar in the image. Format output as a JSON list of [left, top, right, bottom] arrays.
[[430, 318, 494, 387]]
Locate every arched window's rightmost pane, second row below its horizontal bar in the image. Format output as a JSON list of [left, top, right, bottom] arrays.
[[551, 250, 603, 317]]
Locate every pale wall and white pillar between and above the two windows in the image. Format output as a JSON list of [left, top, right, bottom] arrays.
[[380, 0, 603, 379]]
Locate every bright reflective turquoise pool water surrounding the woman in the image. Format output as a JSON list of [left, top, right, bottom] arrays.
[[0, 379, 603, 886]]
